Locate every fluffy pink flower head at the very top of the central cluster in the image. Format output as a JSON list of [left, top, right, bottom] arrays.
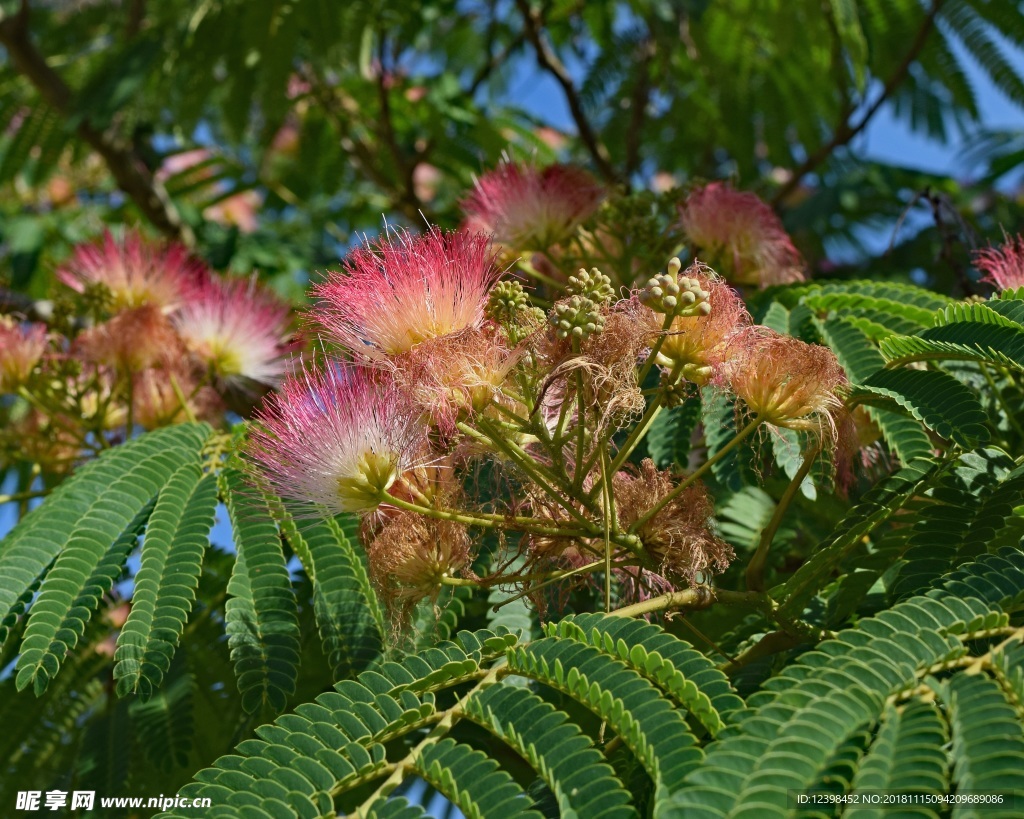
[[462, 162, 604, 251]]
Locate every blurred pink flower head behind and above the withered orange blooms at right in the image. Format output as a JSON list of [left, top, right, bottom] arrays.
[[680, 182, 804, 288]]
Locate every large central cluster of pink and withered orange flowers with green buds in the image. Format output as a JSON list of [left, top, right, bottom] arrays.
[[249, 174, 845, 607]]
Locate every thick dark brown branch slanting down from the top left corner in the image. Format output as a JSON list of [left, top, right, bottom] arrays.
[[0, 0, 196, 247]]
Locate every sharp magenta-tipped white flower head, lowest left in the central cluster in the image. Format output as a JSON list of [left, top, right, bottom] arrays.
[[249, 364, 423, 514]]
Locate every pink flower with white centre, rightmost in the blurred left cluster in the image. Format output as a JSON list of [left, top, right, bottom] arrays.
[[172, 276, 292, 386]]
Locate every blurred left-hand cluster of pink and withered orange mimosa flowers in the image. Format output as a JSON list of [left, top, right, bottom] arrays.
[[0, 232, 294, 471]]
